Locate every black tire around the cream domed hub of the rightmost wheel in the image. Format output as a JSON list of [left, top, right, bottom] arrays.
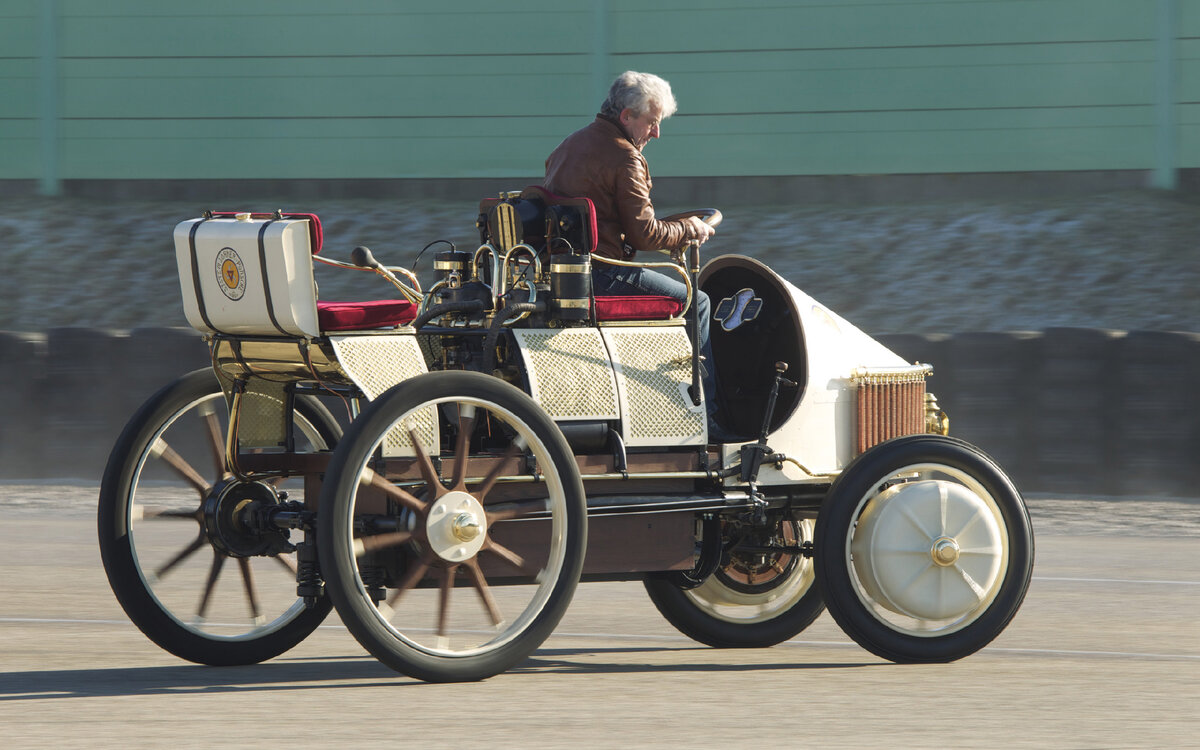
[[815, 434, 1033, 662]]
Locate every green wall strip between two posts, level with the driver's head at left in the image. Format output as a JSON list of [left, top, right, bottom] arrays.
[[62, 56, 595, 118]]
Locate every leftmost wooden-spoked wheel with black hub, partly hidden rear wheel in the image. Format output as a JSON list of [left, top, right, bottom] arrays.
[[97, 370, 340, 665]]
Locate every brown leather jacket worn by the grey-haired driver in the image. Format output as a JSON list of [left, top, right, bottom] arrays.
[[544, 115, 696, 259]]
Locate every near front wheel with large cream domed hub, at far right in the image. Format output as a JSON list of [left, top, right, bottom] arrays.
[[815, 436, 1033, 662]]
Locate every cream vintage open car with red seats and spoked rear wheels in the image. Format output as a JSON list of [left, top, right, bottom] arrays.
[[98, 187, 1033, 682]]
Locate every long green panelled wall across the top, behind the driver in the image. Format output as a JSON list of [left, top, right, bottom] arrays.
[[0, 0, 1200, 192]]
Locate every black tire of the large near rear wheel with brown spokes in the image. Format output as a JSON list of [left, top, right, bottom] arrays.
[[318, 371, 587, 683]]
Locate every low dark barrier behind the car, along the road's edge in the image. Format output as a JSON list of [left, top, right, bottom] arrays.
[[0, 328, 1200, 496]]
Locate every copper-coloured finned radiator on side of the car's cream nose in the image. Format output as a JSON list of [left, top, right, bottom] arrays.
[[852, 365, 932, 454]]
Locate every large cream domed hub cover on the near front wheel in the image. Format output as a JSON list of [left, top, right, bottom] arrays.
[[851, 480, 1008, 620]]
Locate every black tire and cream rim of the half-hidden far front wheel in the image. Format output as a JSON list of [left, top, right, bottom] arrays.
[[643, 513, 824, 648]]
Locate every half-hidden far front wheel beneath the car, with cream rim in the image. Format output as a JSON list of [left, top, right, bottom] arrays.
[[644, 517, 824, 648]]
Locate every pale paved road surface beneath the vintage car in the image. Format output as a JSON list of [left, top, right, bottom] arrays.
[[0, 485, 1200, 750]]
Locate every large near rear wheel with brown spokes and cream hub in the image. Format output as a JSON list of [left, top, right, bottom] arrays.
[[318, 372, 587, 682]]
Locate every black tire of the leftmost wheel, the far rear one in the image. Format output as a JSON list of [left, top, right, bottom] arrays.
[[97, 368, 341, 666]]
